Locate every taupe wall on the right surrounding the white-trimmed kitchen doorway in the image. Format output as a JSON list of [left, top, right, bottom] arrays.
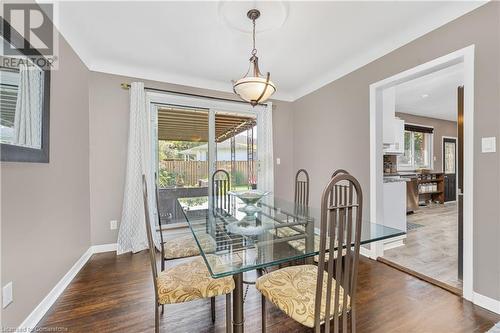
[[293, 2, 500, 300]]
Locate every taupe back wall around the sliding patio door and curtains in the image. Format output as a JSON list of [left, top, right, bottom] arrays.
[[89, 72, 293, 245]]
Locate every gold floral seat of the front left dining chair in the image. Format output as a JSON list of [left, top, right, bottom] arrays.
[[157, 255, 234, 304]]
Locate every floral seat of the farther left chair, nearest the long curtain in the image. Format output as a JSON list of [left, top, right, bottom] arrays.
[[163, 233, 216, 260]]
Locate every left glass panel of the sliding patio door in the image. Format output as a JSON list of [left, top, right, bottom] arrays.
[[156, 105, 210, 225]]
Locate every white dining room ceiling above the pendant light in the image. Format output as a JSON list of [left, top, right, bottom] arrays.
[[56, 1, 484, 100]]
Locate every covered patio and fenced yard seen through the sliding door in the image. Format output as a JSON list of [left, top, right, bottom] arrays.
[[158, 107, 257, 225]]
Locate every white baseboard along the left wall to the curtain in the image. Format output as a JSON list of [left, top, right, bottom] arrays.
[[17, 243, 116, 332]]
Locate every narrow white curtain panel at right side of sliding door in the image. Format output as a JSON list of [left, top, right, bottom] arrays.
[[257, 102, 274, 192]]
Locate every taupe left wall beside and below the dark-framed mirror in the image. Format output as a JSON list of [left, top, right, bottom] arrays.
[[1, 38, 90, 327]]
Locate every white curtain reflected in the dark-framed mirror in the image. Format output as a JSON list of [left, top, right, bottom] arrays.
[[13, 64, 43, 148]]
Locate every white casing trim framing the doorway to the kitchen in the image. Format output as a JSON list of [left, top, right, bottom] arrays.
[[369, 44, 475, 301]]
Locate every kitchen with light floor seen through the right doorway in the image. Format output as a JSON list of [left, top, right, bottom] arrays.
[[378, 67, 462, 293]]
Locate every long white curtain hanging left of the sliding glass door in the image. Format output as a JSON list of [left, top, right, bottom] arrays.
[[117, 82, 159, 254]]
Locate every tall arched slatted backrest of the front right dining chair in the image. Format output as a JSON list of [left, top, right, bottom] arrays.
[[314, 170, 363, 333]]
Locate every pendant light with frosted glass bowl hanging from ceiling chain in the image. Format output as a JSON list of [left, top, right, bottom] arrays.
[[233, 9, 276, 106]]
